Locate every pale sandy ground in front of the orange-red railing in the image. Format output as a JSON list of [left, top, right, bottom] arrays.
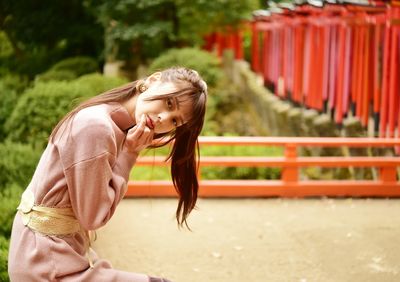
[[94, 199, 400, 282]]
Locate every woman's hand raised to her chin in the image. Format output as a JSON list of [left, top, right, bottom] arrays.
[[125, 115, 154, 154]]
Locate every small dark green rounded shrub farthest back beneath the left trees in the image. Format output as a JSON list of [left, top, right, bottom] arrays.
[[50, 56, 99, 77]]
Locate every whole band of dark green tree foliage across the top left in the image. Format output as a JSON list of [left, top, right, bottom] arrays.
[[0, 0, 260, 77]]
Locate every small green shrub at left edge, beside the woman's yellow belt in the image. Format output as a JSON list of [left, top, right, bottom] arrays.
[[0, 184, 23, 238]]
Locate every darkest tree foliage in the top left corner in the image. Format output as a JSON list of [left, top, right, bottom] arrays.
[[0, 0, 103, 77]]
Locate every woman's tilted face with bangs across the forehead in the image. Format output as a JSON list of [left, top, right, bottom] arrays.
[[135, 80, 192, 134]]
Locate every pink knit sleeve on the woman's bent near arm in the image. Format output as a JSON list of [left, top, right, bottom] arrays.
[[58, 112, 137, 230]]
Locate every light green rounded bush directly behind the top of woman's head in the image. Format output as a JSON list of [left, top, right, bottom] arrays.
[[149, 48, 222, 87]]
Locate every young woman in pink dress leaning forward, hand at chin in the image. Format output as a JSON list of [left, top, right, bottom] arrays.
[[8, 68, 207, 282]]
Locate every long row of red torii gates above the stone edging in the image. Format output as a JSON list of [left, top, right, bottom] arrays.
[[251, 1, 400, 137]]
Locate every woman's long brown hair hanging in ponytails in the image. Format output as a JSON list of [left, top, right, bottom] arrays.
[[49, 67, 207, 226]]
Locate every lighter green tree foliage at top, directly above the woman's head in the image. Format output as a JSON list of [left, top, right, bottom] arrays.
[[91, 0, 259, 64]]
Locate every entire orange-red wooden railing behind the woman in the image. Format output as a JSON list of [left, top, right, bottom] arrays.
[[126, 137, 400, 197]]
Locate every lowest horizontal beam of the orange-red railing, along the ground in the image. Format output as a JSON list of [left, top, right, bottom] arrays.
[[125, 180, 400, 198]]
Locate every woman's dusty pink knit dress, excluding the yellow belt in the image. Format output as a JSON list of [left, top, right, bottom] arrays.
[[8, 103, 149, 282]]
